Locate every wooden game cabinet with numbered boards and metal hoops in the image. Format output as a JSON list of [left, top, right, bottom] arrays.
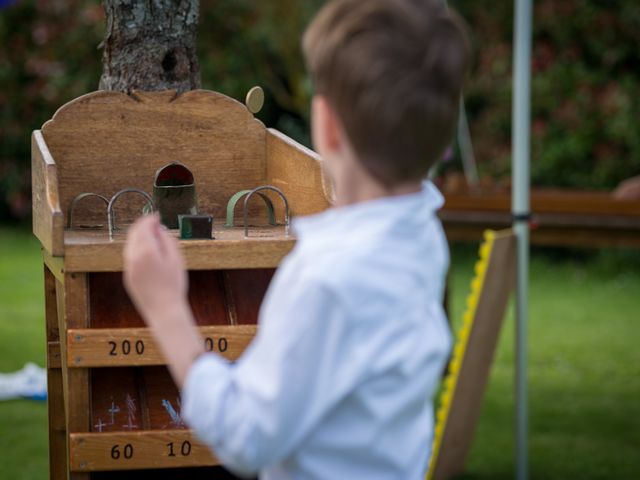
[[32, 90, 331, 480]]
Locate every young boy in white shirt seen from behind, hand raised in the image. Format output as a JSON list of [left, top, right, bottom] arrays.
[[124, 0, 467, 480]]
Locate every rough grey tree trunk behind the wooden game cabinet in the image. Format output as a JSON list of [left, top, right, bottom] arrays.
[[99, 0, 200, 92]]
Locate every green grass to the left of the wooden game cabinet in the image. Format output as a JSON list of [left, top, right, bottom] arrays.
[[0, 227, 48, 480]]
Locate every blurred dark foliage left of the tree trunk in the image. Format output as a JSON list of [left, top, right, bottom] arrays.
[[0, 0, 104, 220]]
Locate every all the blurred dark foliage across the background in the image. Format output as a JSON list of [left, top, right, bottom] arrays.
[[0, 0, 640, 221]]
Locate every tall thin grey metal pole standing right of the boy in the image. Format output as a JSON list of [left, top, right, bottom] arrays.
[[512, 0, 532, 480]]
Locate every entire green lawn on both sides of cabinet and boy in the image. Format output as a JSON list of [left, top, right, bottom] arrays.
[[0, 228, 640, 480]]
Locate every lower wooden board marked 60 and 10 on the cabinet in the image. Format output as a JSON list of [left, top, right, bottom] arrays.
[[69, 430, 219, 472]]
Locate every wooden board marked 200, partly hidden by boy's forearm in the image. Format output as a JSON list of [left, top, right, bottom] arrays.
[[67, 325, 257, 368]]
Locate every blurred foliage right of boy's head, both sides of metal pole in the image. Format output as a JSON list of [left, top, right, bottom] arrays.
[[450, 0, 640, 189]]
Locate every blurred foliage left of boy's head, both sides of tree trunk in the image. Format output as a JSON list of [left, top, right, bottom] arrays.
[[0, 0, 323, 221]]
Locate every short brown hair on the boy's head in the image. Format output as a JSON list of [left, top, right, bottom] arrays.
[[303, 0, 468, 185]]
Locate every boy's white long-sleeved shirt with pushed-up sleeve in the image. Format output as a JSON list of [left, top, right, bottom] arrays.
[[182, 183, 451, 480]]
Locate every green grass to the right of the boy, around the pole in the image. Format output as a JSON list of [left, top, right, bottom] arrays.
[[452, 249, 640, 480]]
